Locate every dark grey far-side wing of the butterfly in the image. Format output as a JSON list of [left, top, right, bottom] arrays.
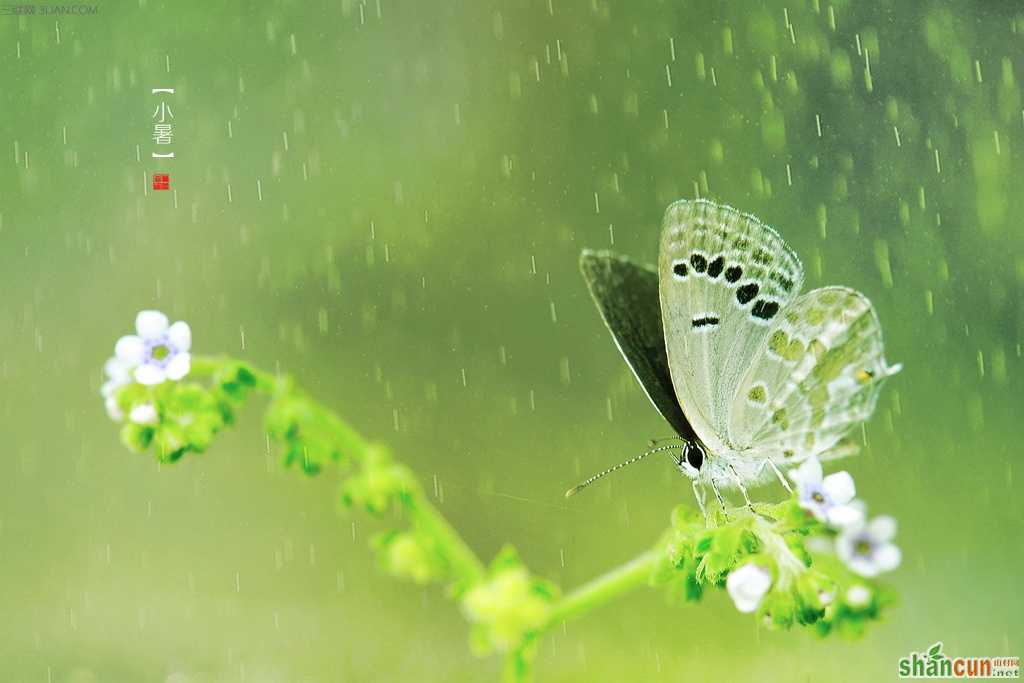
[[580, 250, 693, 439]]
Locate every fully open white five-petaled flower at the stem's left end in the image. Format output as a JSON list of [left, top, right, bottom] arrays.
[[115, 310, 191, 385]]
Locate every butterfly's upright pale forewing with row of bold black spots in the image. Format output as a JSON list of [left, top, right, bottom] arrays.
[[658, 200, 804, 453]]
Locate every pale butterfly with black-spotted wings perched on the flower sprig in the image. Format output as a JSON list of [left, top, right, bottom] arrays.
[[566, 200, 901, 514]]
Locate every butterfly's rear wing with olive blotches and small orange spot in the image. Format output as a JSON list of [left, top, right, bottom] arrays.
[[729, 287, 900, 464]]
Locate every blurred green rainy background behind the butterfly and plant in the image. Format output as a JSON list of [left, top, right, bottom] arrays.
[[0, 0, 1024, 683]]
